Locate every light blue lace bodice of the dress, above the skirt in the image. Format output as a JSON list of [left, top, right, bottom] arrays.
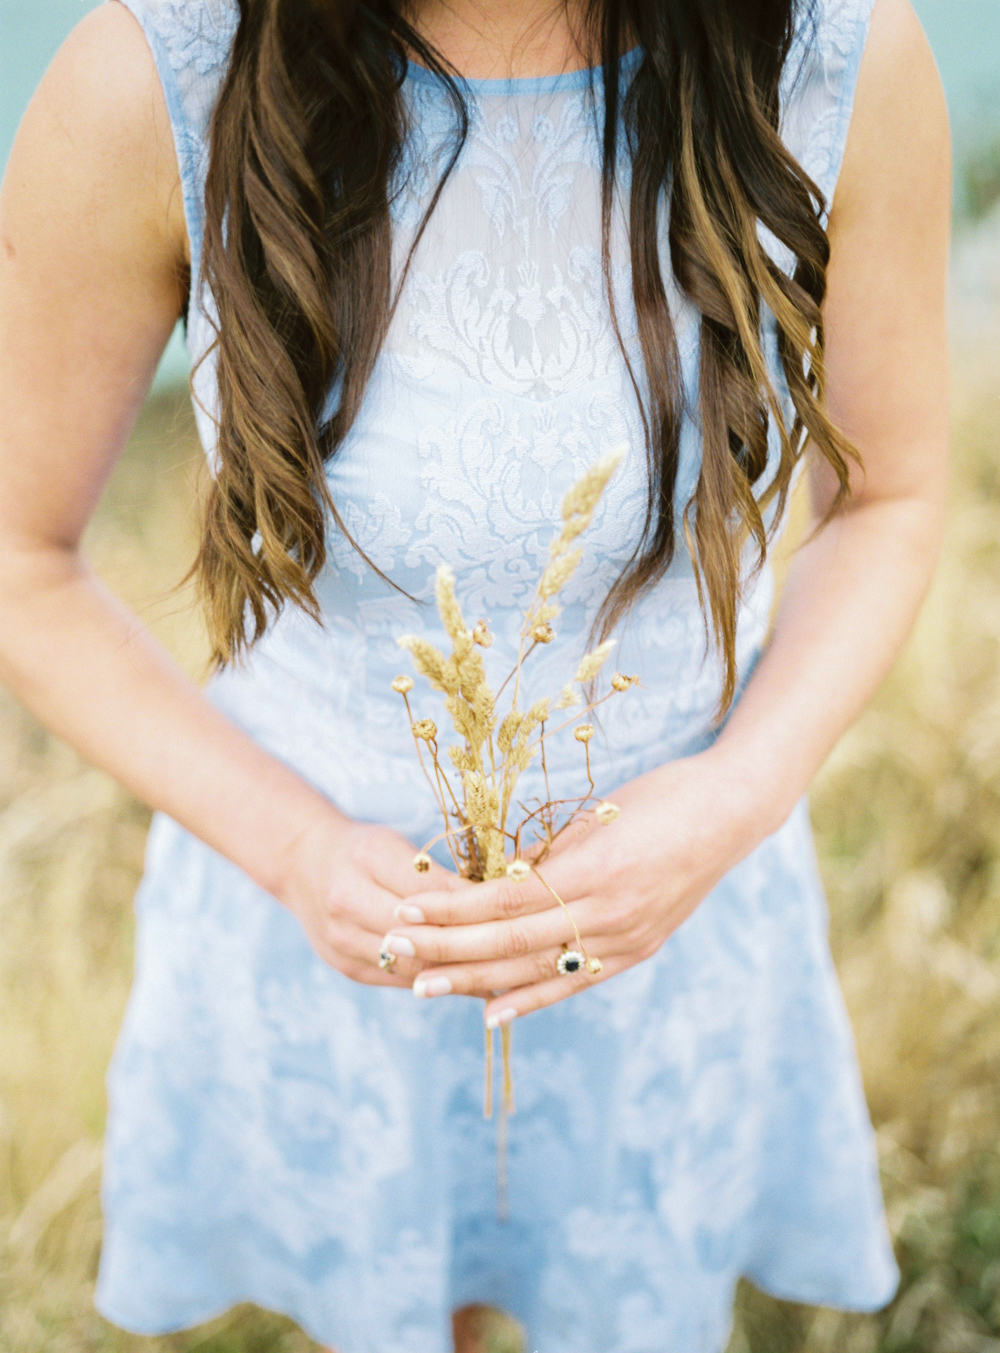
[[150, 10, 858, 812]]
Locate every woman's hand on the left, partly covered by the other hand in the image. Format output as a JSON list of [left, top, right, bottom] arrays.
[[277, 809, 470, 986]]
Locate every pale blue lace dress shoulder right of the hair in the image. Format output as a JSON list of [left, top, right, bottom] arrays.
[[781, 0, 874, 216]]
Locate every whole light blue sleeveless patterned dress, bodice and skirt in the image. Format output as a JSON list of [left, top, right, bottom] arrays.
[[97, 0, 896, 1353]]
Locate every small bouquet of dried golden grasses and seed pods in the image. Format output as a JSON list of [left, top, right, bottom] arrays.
[[392, 446, 639, 1118]]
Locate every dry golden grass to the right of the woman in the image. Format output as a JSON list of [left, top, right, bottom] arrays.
[[729, 214, 1000, 1353]]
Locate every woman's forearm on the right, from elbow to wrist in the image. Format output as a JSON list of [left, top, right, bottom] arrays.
[[709, 491, 945, 838]]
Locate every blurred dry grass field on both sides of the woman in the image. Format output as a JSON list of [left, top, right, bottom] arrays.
[[0, 214, 1000, 1353]]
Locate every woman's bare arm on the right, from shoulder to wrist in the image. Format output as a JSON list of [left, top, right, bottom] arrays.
[[719, 0, 951, 825]]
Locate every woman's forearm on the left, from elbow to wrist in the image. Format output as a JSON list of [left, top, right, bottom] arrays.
[[0, 547, 343, 896]]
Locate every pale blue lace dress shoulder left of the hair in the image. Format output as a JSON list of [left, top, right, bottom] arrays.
[[120, 0, 240, 293]]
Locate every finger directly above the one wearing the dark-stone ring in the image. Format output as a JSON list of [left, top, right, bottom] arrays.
[[386, 898, 605, 965]]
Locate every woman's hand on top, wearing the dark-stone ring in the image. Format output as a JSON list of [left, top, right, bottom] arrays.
[[386, 744, 774, 1027]]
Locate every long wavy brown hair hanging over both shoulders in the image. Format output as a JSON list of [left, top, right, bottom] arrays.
[[194, 0, 854, 708]]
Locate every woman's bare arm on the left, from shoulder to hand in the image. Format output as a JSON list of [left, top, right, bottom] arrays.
[[0, 3, 446, 980]]
